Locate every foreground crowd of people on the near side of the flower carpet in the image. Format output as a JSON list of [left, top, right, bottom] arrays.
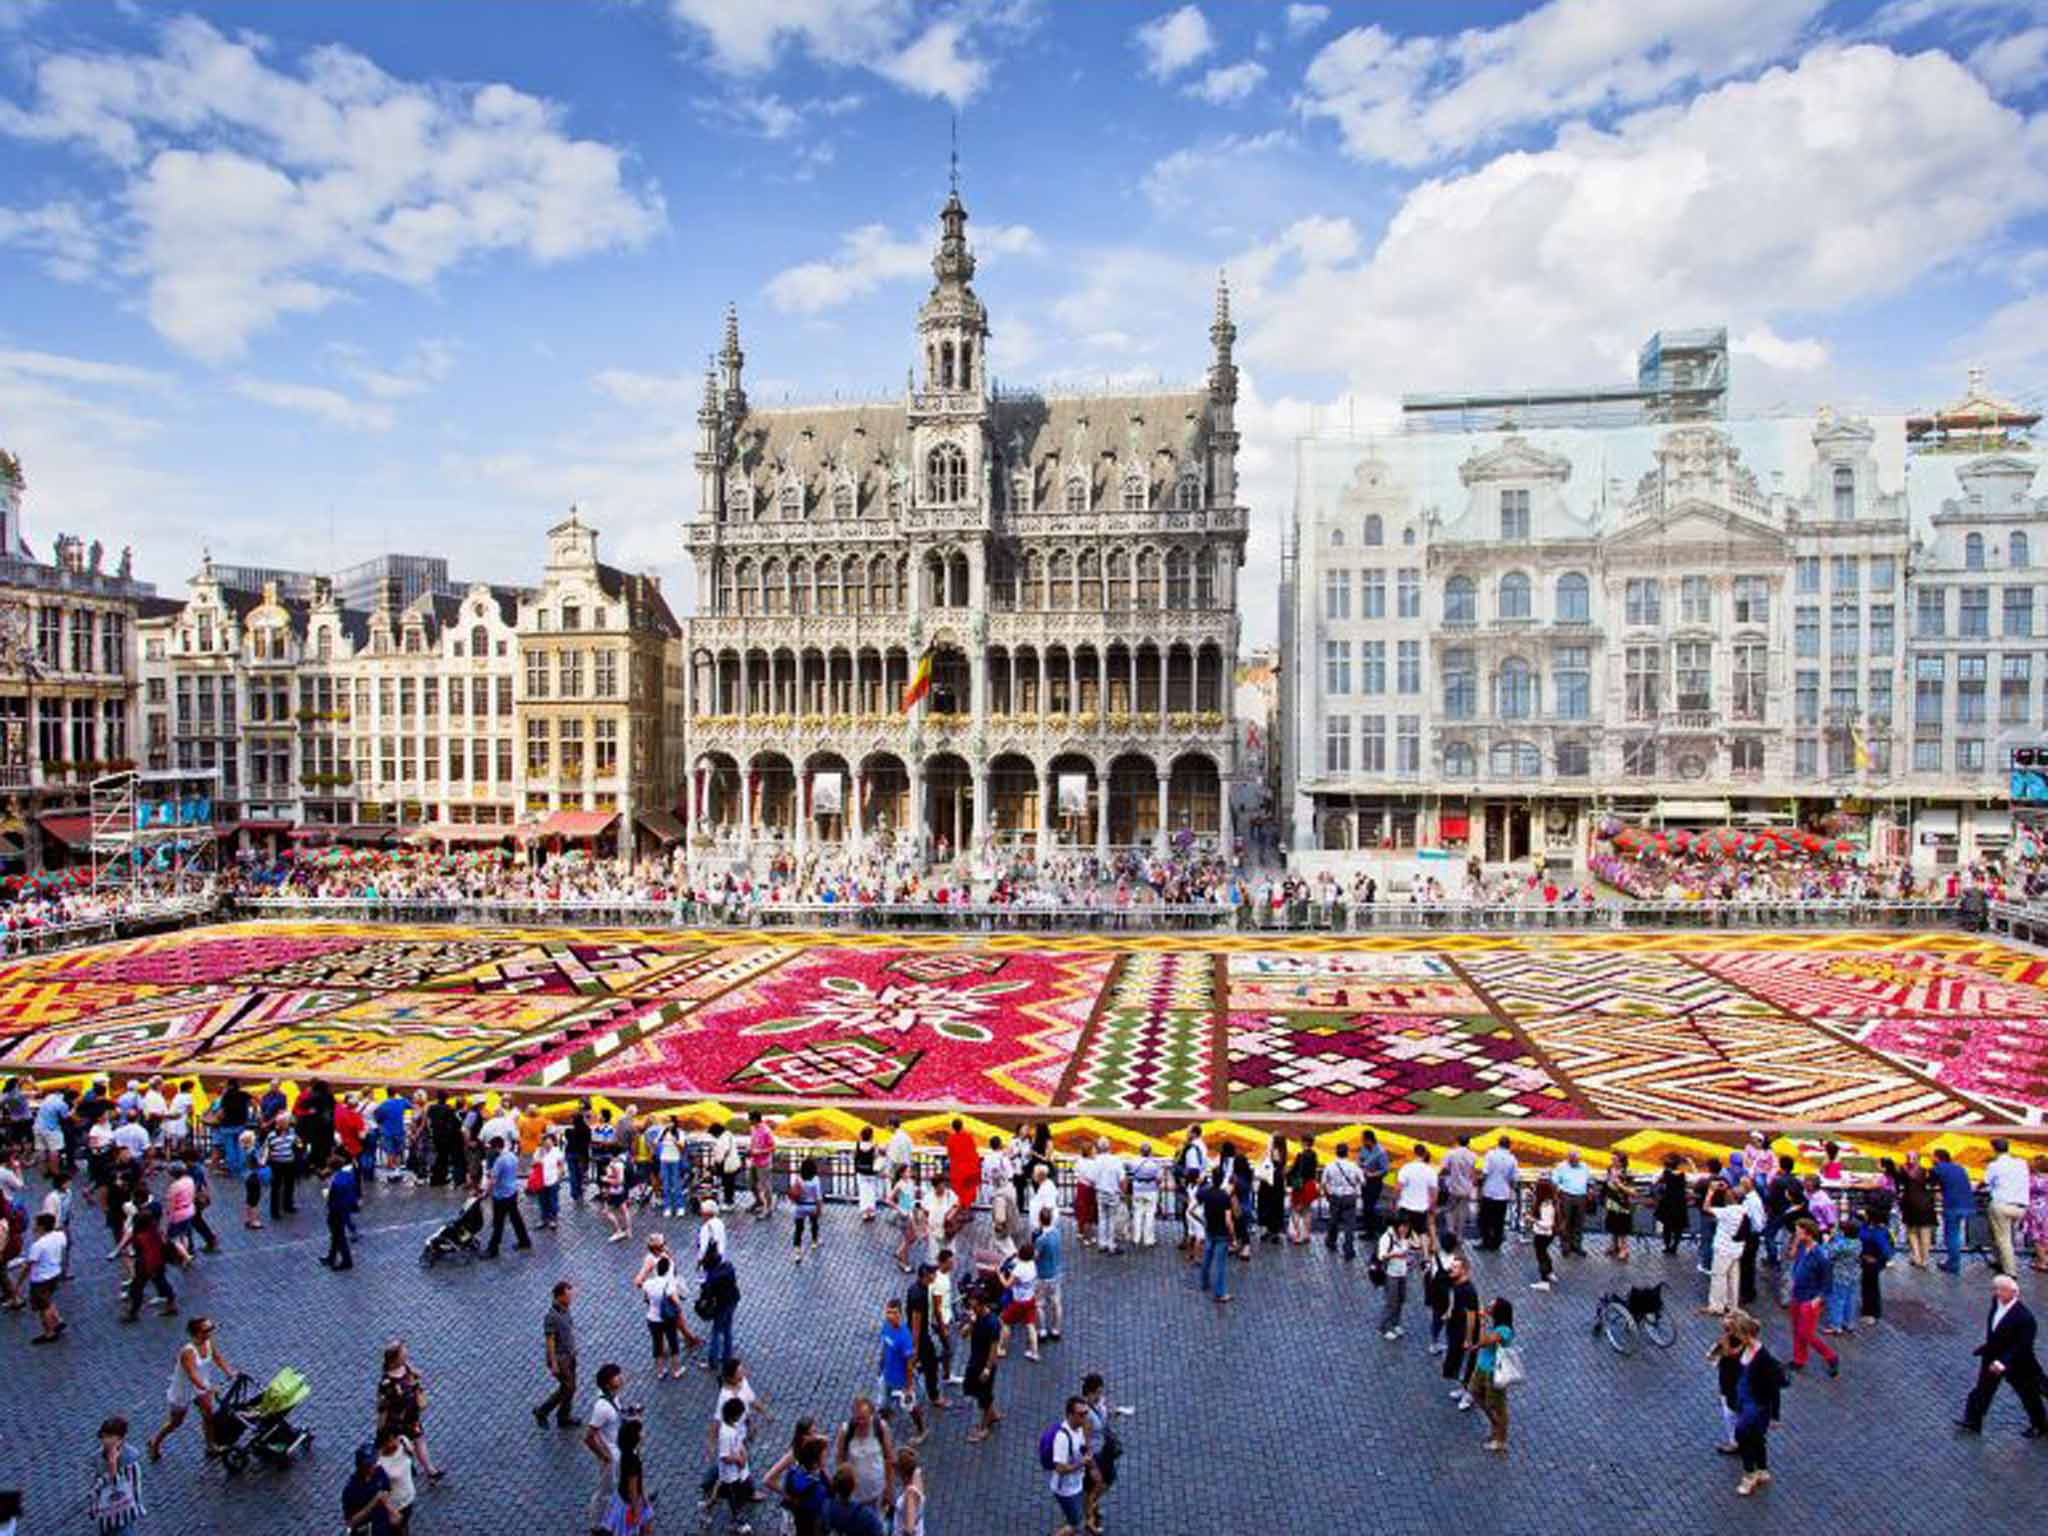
[[0, 1079, 2048, 1536]]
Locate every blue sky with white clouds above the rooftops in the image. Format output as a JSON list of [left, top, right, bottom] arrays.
[[0, 0, 2048, 647]]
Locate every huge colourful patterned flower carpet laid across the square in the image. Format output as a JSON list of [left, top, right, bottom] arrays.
[[0, 924, 2048, 1128]]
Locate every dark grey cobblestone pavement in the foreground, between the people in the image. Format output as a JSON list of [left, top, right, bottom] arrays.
[[0, 1190, 2048, 1536]]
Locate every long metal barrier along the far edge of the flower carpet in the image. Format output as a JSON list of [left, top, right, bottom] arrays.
[[231, 897, 1966, 934]]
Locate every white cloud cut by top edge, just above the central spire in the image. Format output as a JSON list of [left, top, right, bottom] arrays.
[[670, 0, 995, 106]]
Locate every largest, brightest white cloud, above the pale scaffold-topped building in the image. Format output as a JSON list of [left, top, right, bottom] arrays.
[[1231, 45, 2048, 393]]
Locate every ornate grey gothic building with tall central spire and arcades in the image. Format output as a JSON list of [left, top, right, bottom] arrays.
[[684, 190, 1245, 858]]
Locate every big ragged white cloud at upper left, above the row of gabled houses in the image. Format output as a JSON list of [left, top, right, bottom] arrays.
[[0, 16, 664, 360]]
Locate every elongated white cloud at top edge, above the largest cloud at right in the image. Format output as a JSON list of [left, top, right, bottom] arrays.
[[1296, 0, 1825, 166]]
